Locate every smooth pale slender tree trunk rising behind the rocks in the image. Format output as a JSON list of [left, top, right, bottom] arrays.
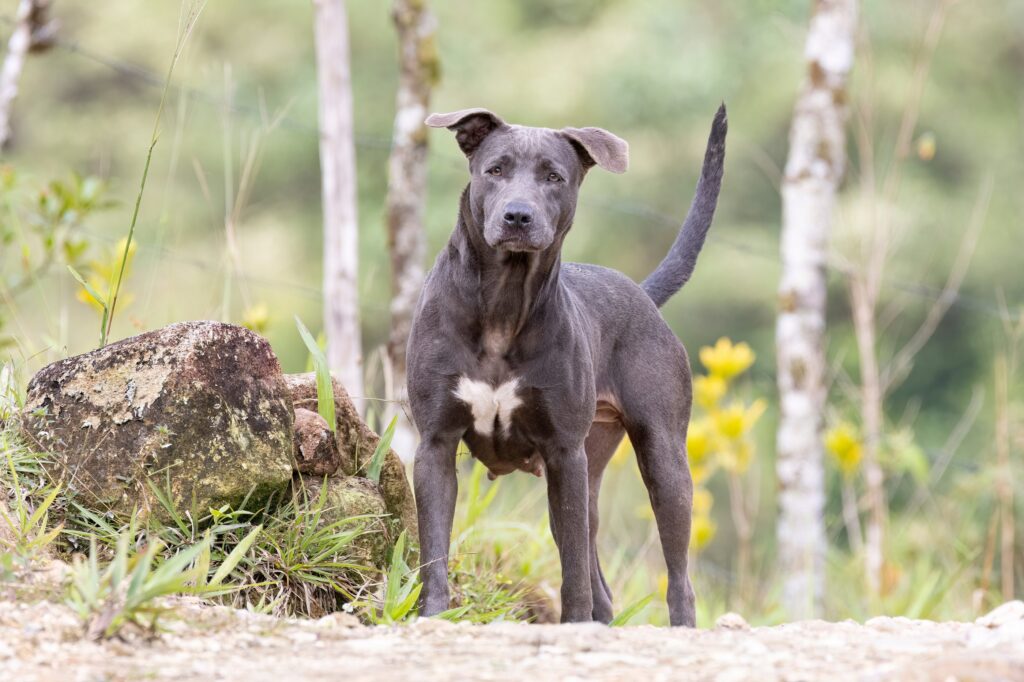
[[313, 0, 364, 412]]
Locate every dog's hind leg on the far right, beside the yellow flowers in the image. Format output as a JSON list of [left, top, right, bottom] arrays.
[[629, 422, 696, 628]]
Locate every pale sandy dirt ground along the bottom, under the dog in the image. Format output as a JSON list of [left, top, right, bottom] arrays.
[[0, 599, 1024, 682]]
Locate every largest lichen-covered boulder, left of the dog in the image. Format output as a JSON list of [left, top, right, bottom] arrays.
[[22, 322, 293, 516]]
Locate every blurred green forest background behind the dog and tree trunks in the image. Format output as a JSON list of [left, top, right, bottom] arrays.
[[0, 0, 1024, 624]]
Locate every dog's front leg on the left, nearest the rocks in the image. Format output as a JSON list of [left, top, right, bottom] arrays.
[[413, 434, 459, 616]]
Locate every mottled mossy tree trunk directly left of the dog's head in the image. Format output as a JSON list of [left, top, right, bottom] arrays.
[[385, 0, 439, 458]]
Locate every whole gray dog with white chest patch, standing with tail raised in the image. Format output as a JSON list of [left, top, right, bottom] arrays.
[[409, 105, 727, 627]]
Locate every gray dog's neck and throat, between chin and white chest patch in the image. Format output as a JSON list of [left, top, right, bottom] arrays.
[[449, 187, 561, 346]]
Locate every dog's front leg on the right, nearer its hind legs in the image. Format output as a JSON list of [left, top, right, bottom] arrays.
[[545, 443, 594, 623]]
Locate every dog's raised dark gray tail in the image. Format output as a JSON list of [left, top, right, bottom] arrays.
[[640, 103, 729, 307]]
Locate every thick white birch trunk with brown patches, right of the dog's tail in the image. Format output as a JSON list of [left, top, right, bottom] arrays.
[[775, 0, 857, 619]]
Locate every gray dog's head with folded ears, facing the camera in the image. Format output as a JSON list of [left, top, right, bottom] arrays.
[[426, 109, 629, 251]]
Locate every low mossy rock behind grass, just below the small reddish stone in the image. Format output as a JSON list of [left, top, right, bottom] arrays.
[[297, 476, 393, 569]]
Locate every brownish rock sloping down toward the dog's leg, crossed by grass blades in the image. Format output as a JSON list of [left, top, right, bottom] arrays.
[[285, 372, 418, 540]]
